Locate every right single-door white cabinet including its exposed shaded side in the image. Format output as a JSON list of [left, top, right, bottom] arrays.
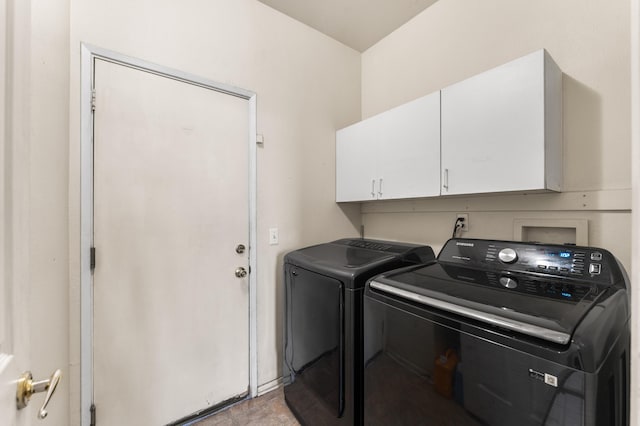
[[441, 50, 562, 195]]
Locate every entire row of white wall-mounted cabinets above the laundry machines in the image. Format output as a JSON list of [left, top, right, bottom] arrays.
[[336, 50, 562, 202]]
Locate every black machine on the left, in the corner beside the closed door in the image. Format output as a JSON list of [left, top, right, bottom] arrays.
[[284, 239, 435, 425]]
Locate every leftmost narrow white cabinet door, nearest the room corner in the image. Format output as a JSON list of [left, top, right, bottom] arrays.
[[336, 116, 381, 202]]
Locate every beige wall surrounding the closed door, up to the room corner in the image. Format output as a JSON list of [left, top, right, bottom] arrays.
[[68, 0, 360, 424]]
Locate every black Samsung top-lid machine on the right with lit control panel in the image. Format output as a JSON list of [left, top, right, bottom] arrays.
[[363, 239, 630, 426]]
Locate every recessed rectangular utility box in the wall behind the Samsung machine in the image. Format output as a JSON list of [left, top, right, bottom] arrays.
[[513, 219, 589, 246]]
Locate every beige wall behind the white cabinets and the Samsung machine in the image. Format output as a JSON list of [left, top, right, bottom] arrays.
[[362, 0, 631, 268]]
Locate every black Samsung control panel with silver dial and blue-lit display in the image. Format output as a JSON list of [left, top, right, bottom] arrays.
[[438, 239, 622, 288]]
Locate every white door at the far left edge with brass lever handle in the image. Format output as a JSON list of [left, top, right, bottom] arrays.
[[0, 0, 26, 426]]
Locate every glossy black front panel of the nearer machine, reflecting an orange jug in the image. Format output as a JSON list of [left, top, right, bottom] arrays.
[[364, 295, 588, 426]]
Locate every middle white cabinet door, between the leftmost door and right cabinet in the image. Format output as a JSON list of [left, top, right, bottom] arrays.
[[377, 91, 440, 199]]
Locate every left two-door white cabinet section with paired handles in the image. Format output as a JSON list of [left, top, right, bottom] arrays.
[[336, 92, 440, 202]]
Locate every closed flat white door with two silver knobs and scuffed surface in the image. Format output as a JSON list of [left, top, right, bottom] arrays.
[[93, 59, 250, 425]]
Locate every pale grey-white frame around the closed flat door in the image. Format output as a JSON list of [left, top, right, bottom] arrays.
[[80, 43, 258, 426]]
